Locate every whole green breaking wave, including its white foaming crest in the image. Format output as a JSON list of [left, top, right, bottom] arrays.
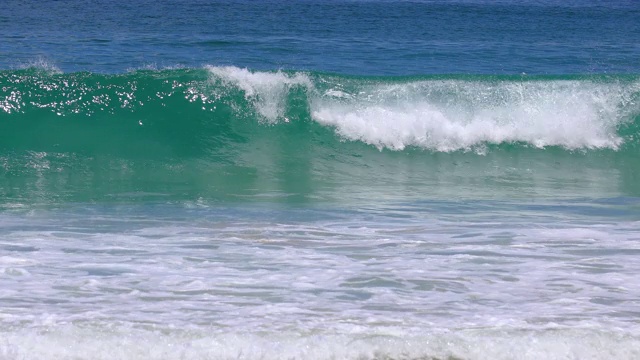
[[0, 66, 640, 200]]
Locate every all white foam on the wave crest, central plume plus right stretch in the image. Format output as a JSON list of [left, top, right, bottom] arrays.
[[207, 66, 640, 152]]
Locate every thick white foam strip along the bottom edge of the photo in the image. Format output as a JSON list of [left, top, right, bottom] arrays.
[[0, 325, 640, 360]]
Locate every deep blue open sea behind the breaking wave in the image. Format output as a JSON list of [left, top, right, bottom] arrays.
[[0, 0, 640, 75]]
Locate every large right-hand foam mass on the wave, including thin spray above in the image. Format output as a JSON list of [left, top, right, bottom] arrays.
[[312, 80, 633, 151]]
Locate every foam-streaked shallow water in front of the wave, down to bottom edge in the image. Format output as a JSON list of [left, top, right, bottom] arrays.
[[0, 202, 640, 359]]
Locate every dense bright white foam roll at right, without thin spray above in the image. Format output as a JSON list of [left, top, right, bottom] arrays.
[[313, 88, 622, 152]]
